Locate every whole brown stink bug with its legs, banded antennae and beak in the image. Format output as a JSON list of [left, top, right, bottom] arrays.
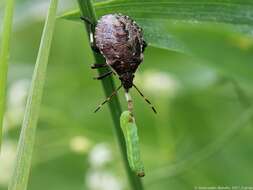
[[81, 14, 156, 113]]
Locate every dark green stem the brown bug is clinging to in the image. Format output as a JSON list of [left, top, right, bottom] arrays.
[[78, 0, 143, 190]]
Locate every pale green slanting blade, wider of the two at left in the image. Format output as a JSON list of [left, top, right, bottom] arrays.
[[8, 0, 58, 190]]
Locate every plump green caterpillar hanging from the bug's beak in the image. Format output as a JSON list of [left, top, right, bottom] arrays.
[[120, 111, 145, 177]]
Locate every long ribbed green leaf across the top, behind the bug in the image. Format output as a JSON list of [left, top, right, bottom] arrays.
[[62, 0, 253, 52]]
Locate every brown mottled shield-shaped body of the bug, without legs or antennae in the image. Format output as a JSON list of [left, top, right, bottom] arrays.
[[95, 14, 144, 90]]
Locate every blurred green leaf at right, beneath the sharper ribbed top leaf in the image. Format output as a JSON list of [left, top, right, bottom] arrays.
[[169, 25, 253, 82]]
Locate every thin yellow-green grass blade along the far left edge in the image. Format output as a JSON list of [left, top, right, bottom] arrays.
[[0, 0, 14, 152]]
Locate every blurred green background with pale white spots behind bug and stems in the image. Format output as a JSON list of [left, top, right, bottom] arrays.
[[0, 0, 253, 190]]
